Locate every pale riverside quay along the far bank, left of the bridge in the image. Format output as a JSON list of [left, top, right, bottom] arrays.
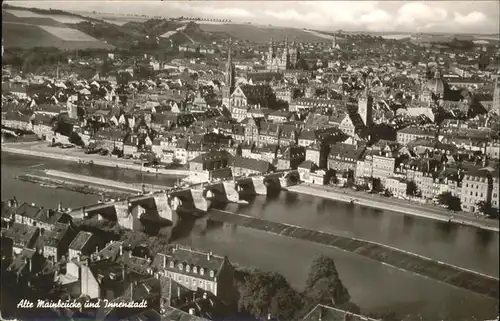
[[1, 142, 189, 177]]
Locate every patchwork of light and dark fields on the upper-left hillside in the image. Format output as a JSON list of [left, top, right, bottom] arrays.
[[2, 7, 113, 50]]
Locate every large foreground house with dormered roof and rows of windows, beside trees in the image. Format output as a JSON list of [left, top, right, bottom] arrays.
[[152, 245, 236, 302]]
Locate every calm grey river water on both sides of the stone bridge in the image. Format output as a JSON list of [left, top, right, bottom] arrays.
[[1, 153, 499, 321]]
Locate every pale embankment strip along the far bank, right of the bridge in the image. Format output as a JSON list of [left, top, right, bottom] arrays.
[[286, 184, 499, 232]]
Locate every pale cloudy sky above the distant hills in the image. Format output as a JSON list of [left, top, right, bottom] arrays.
[[6, 0, 500, 34]]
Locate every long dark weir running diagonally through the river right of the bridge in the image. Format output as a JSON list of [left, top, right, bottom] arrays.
[[207, 210, 499, 299]]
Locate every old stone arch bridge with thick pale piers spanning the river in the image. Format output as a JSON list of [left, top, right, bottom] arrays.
[[70, 171, 299, 229]]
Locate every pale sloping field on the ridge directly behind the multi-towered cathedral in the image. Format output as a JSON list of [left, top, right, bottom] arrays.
[[199, 22, 332, 42]]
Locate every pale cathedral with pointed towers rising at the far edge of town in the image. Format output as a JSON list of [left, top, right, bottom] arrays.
[[266, 38, 299, 72]]
